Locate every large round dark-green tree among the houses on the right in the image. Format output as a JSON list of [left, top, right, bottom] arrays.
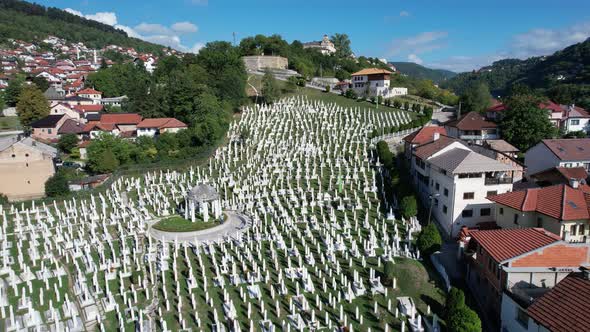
[[500, 95, 557, 151]]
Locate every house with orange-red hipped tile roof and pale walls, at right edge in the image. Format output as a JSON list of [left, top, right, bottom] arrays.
[[488, 180, 590, 242]]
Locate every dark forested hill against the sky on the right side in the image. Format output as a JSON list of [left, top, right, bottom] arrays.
[[442, 39, 590, 107]]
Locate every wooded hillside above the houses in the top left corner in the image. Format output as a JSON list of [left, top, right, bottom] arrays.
[[0, 0, 163, 54]]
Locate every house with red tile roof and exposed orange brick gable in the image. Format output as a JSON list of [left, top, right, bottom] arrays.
[[460, 228, 590, 331]]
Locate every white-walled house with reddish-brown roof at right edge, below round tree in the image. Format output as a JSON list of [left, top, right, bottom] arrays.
[[524, 138, 590, 177]]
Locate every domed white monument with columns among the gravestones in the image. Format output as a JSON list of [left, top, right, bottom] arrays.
[[184, 183, 221, 222]]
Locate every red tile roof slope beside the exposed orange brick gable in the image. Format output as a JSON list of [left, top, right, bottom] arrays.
[[469, 228, 561, 263]]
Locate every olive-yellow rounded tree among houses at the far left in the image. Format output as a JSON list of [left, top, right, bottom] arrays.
[[16, 84, 50, 128]]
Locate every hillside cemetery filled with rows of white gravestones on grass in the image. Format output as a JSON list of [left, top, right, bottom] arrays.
[[0, 96, 445, 331]]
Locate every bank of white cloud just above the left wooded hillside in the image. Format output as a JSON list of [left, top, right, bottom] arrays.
[[65, 8, 202, 52]]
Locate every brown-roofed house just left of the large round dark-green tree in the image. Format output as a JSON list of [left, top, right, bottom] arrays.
[[444, 112, 500, 144]]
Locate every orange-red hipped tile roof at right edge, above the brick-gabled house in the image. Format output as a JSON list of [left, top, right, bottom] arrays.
[[487, 184, 590, 221]]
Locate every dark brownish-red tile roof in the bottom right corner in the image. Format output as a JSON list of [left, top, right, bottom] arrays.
[[527, 273, 590, 332]]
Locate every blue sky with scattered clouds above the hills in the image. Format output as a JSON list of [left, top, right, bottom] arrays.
[[37, 0, 590, 71]]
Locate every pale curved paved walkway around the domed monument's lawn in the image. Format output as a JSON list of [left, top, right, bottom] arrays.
[[148, 211, 250, 242]]
